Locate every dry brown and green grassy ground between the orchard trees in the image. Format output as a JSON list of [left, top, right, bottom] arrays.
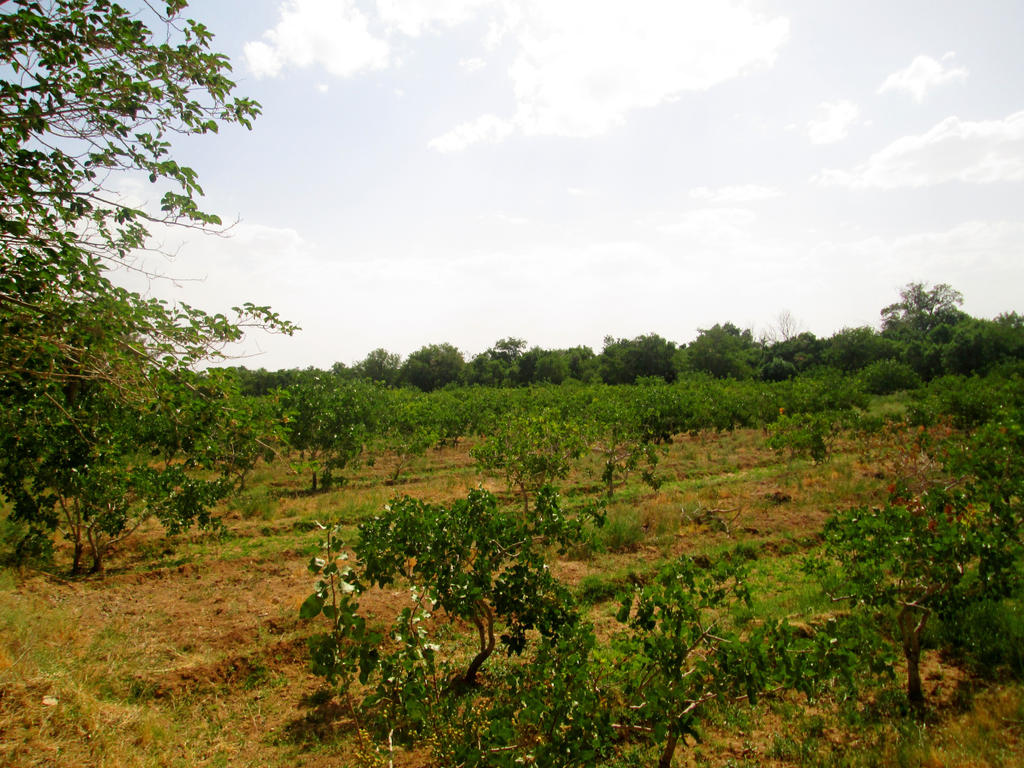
[[0, 415, 1024, 767]]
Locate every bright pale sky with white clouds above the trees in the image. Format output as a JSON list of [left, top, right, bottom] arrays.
[[114, 0, 1024, 370]]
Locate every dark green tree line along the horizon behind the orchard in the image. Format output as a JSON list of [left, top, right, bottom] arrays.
[[236, 283, 1024, 395]]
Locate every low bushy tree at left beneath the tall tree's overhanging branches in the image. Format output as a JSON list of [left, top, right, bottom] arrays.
[[0, 372, 264, 573]]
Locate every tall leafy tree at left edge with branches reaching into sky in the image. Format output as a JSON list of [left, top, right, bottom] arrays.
[[0, 0, 293, 568]]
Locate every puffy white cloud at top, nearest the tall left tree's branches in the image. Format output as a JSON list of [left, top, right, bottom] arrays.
[[244, 0, 389, 78]]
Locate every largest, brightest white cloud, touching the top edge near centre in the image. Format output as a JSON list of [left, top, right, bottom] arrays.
[[432, 0, 790, 148]]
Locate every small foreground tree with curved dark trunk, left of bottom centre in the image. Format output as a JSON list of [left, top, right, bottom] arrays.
[[300, 488, 591, 735]]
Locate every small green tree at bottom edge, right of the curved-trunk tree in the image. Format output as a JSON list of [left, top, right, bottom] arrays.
[[615, 558, 839, 768]]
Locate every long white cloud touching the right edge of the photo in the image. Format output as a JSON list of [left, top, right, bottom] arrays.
[[815, 112, 1024, 189]]
